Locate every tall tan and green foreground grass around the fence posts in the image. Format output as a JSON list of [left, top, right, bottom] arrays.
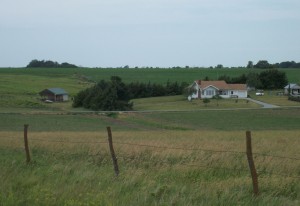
[[0, 130, 300, 206]]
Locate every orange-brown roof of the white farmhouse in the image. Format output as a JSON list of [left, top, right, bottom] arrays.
[[196, 80, 247, 90]]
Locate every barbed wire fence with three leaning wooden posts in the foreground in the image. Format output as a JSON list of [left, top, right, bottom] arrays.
[[1, 124, 300, 195]]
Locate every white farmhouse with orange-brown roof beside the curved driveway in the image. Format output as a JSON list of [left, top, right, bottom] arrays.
[[190, 80, 248, 99]]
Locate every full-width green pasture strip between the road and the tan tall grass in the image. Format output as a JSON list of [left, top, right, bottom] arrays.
[[0, 108, 300, 132]]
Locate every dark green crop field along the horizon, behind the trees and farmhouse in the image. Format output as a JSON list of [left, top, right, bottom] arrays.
[[0, 68, 300, 84]]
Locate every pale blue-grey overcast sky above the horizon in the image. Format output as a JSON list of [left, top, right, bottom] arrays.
[[0, 0, 300, 67]]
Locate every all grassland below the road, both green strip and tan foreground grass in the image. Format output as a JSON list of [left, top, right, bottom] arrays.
[[0, 112, 300, 205]]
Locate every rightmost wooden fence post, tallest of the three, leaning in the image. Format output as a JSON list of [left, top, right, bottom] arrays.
[[246, 131, 259, 195]]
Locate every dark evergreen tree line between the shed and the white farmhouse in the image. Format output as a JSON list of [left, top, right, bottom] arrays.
[[73, 76, 188, 111]]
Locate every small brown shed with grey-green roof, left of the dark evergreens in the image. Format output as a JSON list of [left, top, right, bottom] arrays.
[[39, 88, 69, 102]]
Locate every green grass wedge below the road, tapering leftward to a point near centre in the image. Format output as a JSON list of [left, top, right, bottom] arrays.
[[127, 108, 300, 131]]
